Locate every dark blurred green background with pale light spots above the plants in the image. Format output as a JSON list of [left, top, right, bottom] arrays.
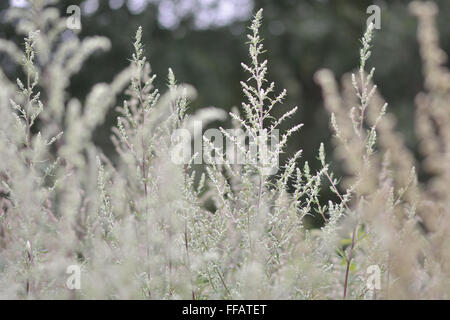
[[0, 0, 450, 186]]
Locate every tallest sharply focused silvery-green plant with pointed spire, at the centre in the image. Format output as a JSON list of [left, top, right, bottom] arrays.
[[190, 10, 334, 298]]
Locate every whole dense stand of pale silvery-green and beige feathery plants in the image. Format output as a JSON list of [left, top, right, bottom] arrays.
[[0, 1, 450, 299]]
